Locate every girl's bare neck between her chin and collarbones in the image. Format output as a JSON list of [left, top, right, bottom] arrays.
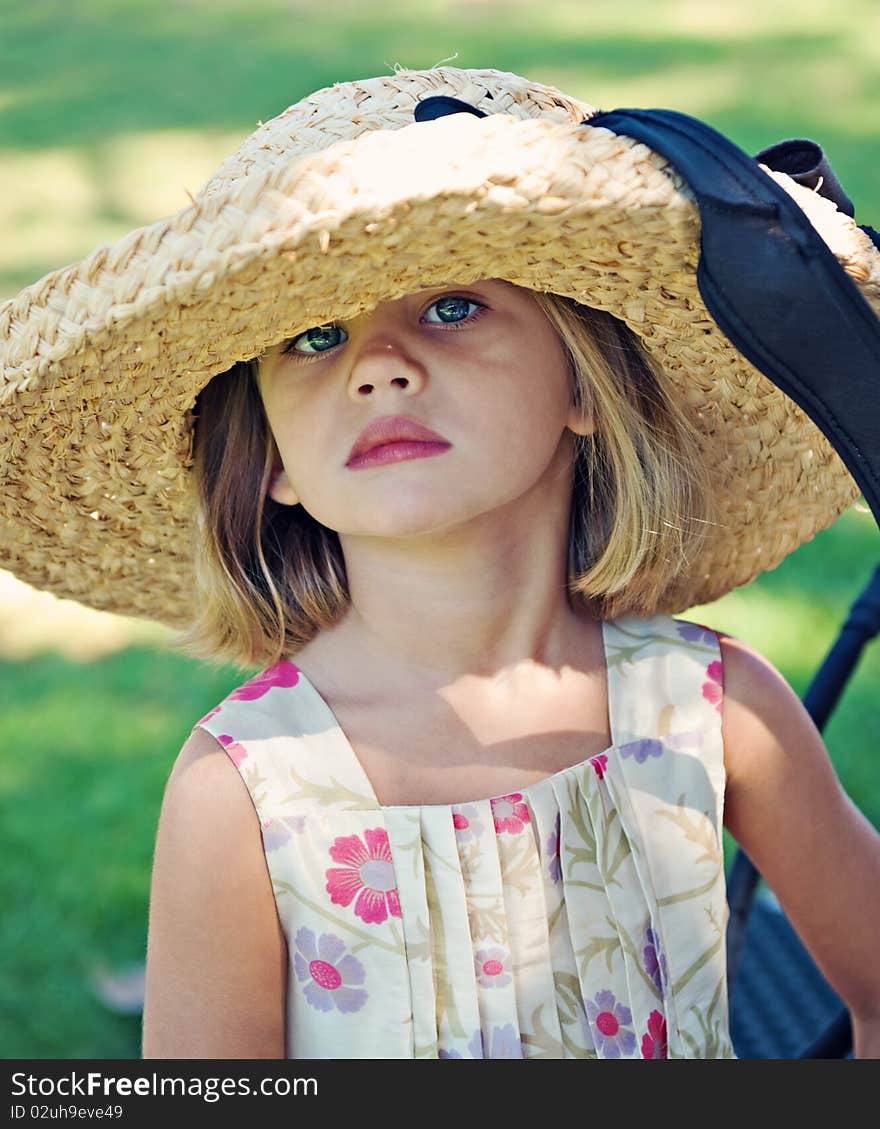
[[310, 474, 590, 693]]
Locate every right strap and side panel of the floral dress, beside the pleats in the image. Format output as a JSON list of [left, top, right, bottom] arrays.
[[605, 615, 732, 1058]]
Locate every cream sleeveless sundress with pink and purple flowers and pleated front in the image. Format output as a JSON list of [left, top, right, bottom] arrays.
[[198, 615, 733, 1059]]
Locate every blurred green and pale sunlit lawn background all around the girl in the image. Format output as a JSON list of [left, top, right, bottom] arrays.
[[0, 0, 880, 1058]]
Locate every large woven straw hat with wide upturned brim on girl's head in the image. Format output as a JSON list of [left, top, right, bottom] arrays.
[[0, 67, 880, 625]]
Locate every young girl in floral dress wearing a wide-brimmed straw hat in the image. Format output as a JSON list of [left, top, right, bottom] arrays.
[[0, 68, 880, 1058]]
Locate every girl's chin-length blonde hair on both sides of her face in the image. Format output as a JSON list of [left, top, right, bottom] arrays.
[[178, 292, 713, 668]]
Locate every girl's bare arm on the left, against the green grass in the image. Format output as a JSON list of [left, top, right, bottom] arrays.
[[142, 729, 287, 1059]]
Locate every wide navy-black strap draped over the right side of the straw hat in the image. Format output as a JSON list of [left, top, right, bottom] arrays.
[[585, 110, 880, 523]]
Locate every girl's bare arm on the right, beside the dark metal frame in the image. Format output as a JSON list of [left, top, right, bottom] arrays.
[[721, 636, 880, 1058]]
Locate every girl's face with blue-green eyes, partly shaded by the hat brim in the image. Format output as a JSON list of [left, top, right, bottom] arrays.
[[259, 279, 592, 537]]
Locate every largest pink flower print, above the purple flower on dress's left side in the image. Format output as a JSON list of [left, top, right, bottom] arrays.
[[325, 828, 400, 925]]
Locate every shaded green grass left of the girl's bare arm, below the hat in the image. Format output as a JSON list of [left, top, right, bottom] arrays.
[[0, 648, 244, 1058]]
